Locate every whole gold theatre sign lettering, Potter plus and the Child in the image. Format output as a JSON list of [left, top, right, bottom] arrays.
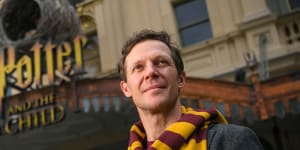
[[0, 36, 87, 134]]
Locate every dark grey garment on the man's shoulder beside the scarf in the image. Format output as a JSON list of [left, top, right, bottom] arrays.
[[207, 124, 263, 150]]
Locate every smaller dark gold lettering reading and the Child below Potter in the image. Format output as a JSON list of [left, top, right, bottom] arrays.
[[3, 94, 65, 135]]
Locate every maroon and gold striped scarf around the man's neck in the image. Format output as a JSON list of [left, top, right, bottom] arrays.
[[128, 106, 227, 150]]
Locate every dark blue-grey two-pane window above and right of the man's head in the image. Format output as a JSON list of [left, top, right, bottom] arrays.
[[174, 0, 212, 46]]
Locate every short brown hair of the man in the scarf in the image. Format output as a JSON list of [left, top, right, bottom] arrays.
[[118, 29, 184, 81]]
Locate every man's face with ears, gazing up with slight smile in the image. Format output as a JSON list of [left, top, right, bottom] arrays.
[[120, 40, 185, 111]]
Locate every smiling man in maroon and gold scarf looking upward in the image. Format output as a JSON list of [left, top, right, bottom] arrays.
[[119, 30, 262, 150]]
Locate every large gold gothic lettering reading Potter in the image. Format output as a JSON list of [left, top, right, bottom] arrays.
[[0, 36, 87, 112]]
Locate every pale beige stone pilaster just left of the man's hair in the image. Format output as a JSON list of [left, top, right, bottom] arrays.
[[95, 0, 124, 72]]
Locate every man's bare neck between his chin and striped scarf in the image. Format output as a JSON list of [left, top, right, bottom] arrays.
[[139, 103, 181, 141]]
